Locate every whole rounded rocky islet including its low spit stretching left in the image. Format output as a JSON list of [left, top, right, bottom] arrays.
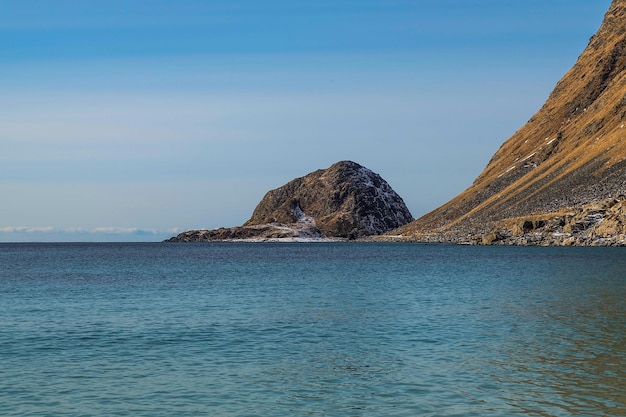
[[169, 161, 413, 242]]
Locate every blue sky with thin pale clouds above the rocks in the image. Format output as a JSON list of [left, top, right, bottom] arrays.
[[0, 0, 611, 242]]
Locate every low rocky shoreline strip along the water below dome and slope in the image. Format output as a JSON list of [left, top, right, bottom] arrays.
[[166, 196, 626, 247]]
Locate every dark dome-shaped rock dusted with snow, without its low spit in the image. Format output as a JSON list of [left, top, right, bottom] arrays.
[[244, 161, 413, 238]]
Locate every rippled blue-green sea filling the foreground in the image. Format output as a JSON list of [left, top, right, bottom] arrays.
[[0, 242, 626, 417]]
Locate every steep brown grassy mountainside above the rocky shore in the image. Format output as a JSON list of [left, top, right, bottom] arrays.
[[399, 0, 626, 236]]
